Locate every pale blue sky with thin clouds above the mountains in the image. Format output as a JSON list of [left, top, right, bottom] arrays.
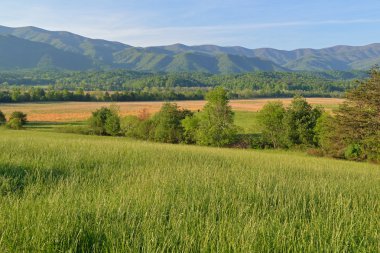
[[0, 0, 380, 50]]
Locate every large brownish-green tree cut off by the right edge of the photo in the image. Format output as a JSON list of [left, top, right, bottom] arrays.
[[334, 67, 380, 161]]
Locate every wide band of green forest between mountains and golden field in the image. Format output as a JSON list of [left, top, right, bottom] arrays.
[[0, 70, 366, 103]]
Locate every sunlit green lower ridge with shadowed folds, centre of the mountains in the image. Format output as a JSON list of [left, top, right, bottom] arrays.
[[114, 48, 287, 73]]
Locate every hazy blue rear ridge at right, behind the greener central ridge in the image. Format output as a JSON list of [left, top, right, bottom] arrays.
[[149, 44, 380, 71]]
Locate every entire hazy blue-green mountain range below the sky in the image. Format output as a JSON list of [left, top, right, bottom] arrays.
[[0, 26, 380, 74]]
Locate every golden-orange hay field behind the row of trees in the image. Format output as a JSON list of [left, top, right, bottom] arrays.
[[0, 98, 343, 122]]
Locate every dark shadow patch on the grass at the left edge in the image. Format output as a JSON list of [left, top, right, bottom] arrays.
[[0, 162, 67, 196]]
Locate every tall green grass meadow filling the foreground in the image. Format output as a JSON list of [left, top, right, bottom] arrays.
[[0, 130, 380, 252]]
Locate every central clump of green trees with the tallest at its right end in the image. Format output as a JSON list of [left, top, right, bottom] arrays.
[[98, 87, 237, 147]]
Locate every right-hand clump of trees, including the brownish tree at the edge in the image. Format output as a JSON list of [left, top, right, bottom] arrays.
[[255, 68, 380, 162]]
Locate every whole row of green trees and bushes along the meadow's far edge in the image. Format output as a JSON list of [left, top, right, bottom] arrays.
[[0, 68, 380, 162]]
